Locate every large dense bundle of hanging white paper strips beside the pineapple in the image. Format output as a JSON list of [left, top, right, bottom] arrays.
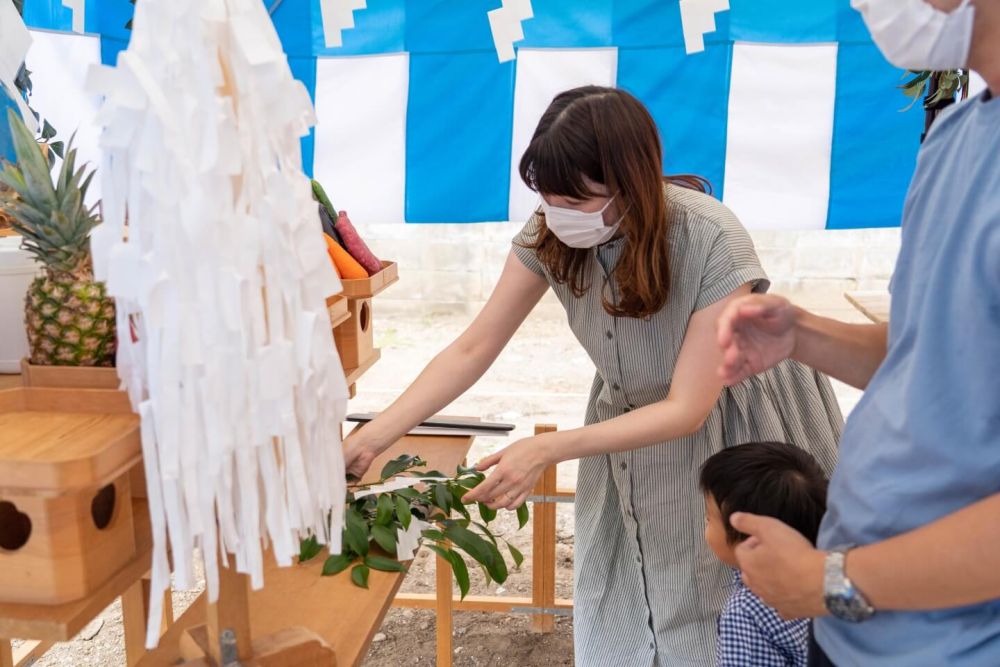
[[88, 0, 347, 647]]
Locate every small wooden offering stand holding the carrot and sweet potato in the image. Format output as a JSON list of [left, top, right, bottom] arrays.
[[333, 262, 399, 376]]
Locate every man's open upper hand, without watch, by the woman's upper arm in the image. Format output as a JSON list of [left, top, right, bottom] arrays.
[[717, 294, 797, 385]]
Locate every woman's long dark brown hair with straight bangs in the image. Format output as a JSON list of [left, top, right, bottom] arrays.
[[520, 86, 708, 317]]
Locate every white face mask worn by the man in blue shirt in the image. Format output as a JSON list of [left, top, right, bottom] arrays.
[[851, 0, 975, 71]]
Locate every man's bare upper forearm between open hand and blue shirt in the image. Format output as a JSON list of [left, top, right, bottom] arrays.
[[792, 308, 888, 389]]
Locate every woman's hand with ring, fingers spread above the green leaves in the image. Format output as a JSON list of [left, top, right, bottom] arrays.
[[464, 436, 549, 510]]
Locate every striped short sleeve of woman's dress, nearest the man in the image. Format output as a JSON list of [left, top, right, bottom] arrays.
[[694, 218, 771, 311]]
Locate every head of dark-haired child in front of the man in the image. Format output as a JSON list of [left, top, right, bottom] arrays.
[[700, 442, 827, 567]]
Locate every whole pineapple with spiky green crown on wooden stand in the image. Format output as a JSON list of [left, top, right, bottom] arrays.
[[0, 109, 116, 366]]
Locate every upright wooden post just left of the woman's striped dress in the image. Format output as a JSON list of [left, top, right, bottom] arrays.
[[531, 424, 556, 632]]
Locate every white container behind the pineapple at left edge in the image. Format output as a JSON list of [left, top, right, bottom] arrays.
[[0, 236, 41, 373]]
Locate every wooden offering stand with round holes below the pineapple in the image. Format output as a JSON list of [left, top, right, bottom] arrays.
[[0, 387, 141, 605]]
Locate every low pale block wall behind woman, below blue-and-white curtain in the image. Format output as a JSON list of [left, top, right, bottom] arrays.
[[359, 222, 899, 317]]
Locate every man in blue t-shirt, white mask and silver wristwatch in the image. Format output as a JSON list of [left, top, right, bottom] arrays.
[[719, 0, 1000, 667]]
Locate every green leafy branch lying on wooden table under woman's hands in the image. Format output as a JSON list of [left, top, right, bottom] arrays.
[[299, 455, 528, 598]]
